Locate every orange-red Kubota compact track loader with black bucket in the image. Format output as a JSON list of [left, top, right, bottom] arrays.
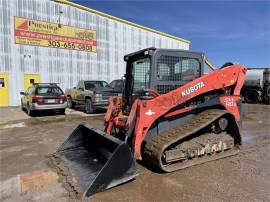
[[52, 48, 246, 196]]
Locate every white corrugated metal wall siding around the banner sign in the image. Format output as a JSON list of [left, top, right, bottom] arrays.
[[0, 0, 189, 106]]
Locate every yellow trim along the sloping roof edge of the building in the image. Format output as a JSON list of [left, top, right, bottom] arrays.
[[55, 0, 191, 44]]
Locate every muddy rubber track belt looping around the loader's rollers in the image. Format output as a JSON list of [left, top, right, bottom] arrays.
[[143, 109, 239, 172]]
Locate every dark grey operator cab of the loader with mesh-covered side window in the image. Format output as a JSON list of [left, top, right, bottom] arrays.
[[124, 48, 204, 105]]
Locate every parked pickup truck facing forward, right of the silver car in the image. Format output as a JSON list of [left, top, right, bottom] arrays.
[[65, 80, 118, 114]]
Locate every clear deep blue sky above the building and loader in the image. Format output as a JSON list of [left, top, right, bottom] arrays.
[[72, 0, 270, 67]]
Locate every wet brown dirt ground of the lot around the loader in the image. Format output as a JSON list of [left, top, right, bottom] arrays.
[[0, 105, 270, 201]]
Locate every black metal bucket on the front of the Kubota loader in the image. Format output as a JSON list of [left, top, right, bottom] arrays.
[[54, 125, 138, 197]]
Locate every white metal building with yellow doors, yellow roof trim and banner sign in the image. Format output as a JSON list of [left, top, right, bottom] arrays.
[[0, 0, 190, 106]]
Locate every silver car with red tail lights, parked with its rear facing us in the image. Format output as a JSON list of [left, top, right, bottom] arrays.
[[20, 83, 67, 115]]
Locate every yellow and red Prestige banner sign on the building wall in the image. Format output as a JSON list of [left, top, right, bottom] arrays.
[[14, 16, 97, 52]]
